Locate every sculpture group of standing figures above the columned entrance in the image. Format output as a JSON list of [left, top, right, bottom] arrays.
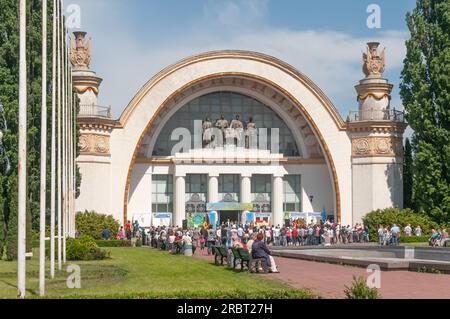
[[203, 115, 258, 148]]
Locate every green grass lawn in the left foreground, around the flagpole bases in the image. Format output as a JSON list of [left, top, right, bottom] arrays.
[[0, 248, 314, 299]]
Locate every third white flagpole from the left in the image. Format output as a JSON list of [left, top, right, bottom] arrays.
[[50, 0, 57, 279]]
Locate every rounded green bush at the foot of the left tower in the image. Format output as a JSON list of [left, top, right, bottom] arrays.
[[76, 211, 120, 240]]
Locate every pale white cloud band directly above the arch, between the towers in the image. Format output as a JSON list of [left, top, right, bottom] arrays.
[[94, 29, 406, 115]]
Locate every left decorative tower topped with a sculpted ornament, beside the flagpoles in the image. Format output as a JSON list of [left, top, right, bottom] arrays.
[[70, 32, 116, 213]]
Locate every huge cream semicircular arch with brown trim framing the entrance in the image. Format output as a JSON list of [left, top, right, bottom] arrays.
[[104, 51, 352, 224]]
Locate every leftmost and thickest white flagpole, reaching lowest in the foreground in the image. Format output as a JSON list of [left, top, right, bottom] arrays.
[[17, 0, 27, 298]]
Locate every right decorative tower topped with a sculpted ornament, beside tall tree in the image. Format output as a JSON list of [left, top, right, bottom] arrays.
[[347, 42, 407, 223]]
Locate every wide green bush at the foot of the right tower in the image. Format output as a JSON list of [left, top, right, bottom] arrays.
[[363, 208, 439, 241]]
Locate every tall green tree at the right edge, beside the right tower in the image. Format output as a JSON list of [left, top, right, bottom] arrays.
[[400, 0, 450, 223]]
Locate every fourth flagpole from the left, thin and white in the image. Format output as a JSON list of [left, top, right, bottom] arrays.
[[56, 0, 62, 270]]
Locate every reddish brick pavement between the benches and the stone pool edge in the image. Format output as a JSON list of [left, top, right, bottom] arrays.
[[195, 250, 450, 299]]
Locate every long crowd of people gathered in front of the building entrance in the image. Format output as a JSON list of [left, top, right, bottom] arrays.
[[94, 220, 445, 252]]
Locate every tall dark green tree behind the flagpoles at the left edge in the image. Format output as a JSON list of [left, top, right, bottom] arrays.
[[0, 0, 80, 259]]
